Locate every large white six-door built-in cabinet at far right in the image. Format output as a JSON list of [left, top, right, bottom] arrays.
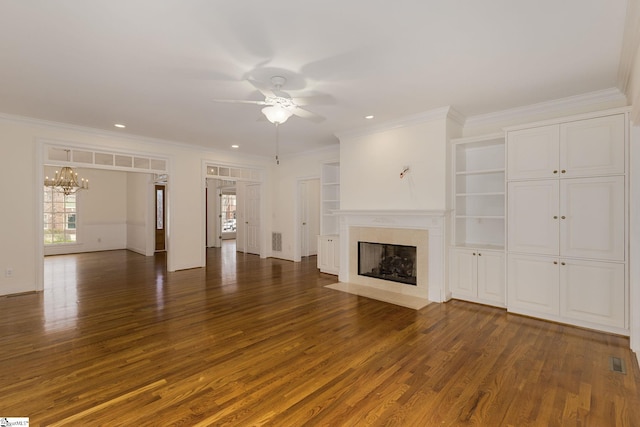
[[506, 111, 628, 334]]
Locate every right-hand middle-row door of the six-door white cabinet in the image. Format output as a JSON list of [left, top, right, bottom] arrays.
[[560, 176, 625, 261]]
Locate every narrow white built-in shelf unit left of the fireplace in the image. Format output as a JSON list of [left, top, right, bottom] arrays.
[[318, 162, 340, 274]]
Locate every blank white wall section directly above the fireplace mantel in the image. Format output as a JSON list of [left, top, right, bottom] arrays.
[[340, 118, 449, 210]]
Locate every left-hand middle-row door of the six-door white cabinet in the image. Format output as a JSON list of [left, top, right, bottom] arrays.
[[507, 180, 559, 255]]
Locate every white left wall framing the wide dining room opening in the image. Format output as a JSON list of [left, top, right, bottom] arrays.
[[0, 116, 270, 295]]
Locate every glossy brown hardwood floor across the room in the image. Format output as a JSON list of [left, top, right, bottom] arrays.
[[0, 246, 640, 426]]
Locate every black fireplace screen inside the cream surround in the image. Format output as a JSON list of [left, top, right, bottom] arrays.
[[358, 242, 417, 286]]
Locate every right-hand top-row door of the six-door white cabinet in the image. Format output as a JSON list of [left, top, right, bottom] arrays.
[[560, 114, 625, 178]]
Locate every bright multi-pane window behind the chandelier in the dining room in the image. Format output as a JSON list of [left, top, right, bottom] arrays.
[[44, 186, 77, 245]]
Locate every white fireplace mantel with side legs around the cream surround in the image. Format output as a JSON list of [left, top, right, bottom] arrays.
[[334, 209, 448, 302]]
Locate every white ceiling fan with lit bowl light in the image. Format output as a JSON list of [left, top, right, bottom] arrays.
[[214, 76, 324, 125]]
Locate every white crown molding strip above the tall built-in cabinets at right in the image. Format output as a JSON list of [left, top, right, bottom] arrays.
[[465, 87, 626, 127]]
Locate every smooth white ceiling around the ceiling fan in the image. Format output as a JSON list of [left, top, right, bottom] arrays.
[[0, 0, 627, 156]]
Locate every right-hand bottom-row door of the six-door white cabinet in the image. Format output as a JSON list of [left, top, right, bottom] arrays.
[[560, 259, 626, 328]]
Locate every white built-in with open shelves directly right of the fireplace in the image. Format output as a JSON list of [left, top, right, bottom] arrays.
[[449, 134, 506, 307]]
